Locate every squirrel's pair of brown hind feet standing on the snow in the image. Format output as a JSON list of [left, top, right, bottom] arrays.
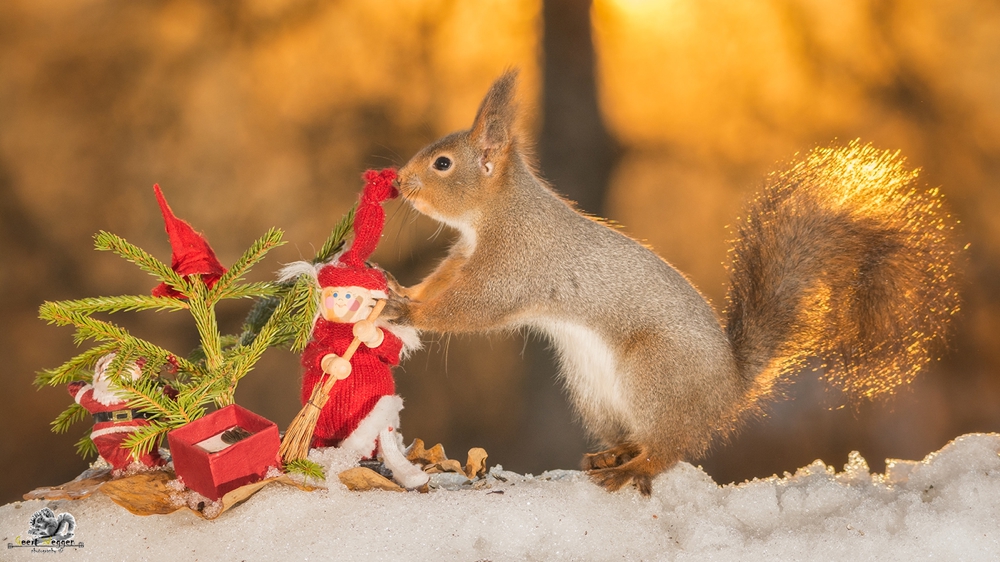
[[583, 444, 668, 496]]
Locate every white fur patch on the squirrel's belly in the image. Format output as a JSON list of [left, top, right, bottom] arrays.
[[531, 318, 628, 430]]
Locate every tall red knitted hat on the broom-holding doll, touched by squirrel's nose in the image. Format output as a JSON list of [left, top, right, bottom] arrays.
[[316, 168, 399, 298]]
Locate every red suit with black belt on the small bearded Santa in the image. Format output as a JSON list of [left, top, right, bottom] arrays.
[[69, 381, 165, 471]]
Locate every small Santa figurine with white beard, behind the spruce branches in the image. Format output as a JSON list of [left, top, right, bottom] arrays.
[[69, 353, 166, 472]]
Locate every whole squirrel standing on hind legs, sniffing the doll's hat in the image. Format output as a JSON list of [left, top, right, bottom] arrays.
[[383, 71, 959, 495]]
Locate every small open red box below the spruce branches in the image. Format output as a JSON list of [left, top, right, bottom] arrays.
[[167, 404, 281, 501]]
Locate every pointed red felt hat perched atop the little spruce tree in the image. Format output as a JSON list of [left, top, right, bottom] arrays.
[[153, 184, 226, 298]]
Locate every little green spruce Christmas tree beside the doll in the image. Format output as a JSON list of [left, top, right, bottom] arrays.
[[35, 188, 353, 457]]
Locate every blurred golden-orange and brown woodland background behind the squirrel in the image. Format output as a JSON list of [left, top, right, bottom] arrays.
[[0, 0, 1000, 502]]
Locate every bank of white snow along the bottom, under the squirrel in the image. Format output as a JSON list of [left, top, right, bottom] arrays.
[[0, 434, 1000, 562]]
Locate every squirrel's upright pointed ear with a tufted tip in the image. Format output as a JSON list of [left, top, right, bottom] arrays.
[[470, 70, 518, 173]]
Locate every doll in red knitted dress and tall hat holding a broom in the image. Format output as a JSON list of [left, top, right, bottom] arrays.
[[282, 169, 428, 489]]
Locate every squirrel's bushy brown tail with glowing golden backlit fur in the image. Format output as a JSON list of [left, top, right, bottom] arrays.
[[725, 141, 959, 403]]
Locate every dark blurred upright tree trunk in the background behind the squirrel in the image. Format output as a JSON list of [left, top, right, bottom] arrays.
[[520, 0, 616, 470]]
